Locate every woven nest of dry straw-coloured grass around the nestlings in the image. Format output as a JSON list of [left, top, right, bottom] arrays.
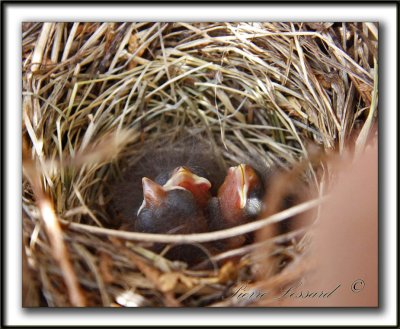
[[22, 23, 378, 307]]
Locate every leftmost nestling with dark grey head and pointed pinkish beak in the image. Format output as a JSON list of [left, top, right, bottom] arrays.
[[135, 174, 211, 264]]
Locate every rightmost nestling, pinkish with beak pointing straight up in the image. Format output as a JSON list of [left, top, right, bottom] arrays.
[[208, 164, 264, 248]]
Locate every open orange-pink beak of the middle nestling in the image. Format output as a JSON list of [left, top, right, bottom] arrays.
[[164, 167, 211, 206]]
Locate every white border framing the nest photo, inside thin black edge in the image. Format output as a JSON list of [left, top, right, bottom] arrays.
[[2, 4, 397, 326]]
